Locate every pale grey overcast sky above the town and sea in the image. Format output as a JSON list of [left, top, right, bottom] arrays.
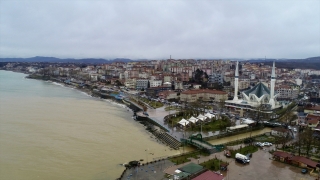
[[0, 0, 320, 59]]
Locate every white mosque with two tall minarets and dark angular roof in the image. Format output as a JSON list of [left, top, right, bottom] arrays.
[[225, 62, 282, 115]]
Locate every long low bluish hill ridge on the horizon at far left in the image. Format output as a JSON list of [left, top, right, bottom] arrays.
[[0, 56, 133, 64]]
